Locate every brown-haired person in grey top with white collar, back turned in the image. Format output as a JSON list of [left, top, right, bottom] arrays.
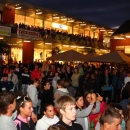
[[54, 79, 69, 103]]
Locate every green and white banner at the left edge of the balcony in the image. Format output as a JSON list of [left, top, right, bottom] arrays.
[[0, 26, 11, 36]]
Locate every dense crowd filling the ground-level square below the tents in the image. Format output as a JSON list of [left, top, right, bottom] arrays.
[[0, 62, 130, 130]]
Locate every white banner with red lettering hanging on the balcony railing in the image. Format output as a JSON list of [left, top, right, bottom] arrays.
[[17, 28, 39, 40]]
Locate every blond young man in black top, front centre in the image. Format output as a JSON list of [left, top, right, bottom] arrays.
[[56, 95, 83, 130]]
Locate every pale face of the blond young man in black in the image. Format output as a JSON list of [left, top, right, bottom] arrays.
[[60, 103, 76, 121]]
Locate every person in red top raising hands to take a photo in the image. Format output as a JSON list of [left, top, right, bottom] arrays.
[[84, 91, 107, 127]]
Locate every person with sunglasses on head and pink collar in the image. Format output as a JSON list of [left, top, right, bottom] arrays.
[[14, 96, 35, 130]]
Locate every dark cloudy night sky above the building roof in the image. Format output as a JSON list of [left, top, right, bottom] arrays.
[[23, 0, 130, 28]]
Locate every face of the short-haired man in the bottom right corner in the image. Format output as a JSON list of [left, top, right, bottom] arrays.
[[106, 118, 121, 130]]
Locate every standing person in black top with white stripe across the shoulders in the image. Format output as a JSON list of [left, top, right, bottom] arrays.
[[21, 68, 30, 95]]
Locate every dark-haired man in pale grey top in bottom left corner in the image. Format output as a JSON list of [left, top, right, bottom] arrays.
[[0, 91, 17, 130]]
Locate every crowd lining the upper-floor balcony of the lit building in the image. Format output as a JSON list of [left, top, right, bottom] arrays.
[[0, 22, 98, 45]]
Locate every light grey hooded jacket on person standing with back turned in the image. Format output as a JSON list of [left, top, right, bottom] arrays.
[[27, 85, 38, 107]]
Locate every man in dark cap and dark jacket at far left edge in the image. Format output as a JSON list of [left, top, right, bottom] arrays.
[[0, 73, 14, 91]]
